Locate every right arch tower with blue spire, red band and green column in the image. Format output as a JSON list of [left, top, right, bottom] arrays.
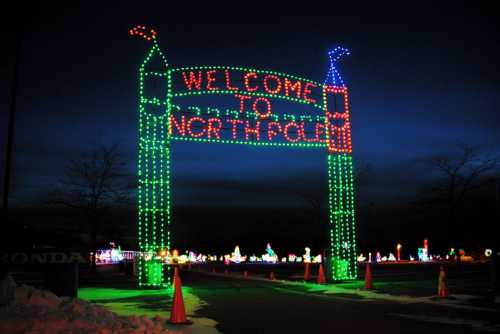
[[323, 47, 357, 281]]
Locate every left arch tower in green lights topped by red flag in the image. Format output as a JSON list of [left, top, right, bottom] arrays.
[[130, 26, 171, 287]]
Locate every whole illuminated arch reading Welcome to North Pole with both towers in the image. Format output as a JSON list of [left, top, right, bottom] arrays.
[[130, 26, 357, 286]]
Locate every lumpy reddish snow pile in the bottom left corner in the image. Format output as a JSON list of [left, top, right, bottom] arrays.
[[0, 285, 173, 334]]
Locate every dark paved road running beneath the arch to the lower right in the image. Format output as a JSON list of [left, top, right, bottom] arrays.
[[182, 271, 500, 334]]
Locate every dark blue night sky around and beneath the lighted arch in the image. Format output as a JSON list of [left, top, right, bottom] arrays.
[[0, 1, 500, 248]]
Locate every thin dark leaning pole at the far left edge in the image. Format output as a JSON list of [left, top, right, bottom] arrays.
[[2, 14, 23, 223]]
